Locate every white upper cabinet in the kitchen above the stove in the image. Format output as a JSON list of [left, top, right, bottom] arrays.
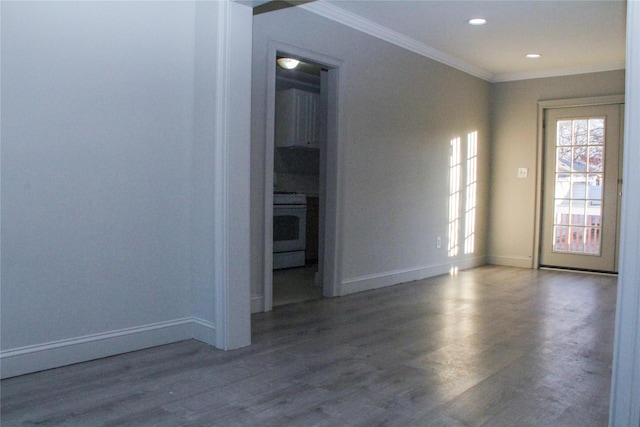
[[275, 89, 323, 148]]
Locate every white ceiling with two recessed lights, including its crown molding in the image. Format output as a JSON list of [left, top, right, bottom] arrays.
[[268, 0, 626, 81]]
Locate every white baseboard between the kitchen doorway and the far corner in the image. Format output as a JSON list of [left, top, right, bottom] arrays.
[[340, 257, 486, 295]]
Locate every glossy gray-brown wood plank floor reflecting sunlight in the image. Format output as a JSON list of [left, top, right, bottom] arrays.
[[1, 266, 616, 427]]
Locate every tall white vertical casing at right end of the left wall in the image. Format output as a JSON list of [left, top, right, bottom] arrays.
[[212, 0, 253, 350]]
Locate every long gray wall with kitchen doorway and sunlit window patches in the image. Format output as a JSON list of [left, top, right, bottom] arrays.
[[251, 8, 490, 308]]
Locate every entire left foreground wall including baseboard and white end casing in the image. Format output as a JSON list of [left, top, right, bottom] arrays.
[[0, 2, 251, 377]]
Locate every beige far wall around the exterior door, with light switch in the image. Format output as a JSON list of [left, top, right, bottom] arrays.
[[489, 70, 625, 267]]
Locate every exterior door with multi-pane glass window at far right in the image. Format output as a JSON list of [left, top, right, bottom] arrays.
[[540, 104, 622, 272]]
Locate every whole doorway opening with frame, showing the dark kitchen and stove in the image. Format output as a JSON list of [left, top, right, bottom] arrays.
[[264, 44, 340, 311]]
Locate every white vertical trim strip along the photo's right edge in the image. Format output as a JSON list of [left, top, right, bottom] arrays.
[[609, 1, 640, 427]]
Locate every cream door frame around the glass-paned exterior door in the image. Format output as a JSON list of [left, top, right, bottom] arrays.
[[533, 95, 624, 268]]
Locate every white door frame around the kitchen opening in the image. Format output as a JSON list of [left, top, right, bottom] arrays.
[[263, 41, 344, 311]]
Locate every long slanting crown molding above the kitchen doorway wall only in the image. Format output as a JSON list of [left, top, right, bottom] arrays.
[[298, 0, 493, 81]]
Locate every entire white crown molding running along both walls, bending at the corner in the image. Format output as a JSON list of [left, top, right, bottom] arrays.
[[298, 0, 625, 83]]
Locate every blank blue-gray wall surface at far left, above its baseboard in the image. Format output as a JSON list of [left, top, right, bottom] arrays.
[[1, 2, 194, 349]]
